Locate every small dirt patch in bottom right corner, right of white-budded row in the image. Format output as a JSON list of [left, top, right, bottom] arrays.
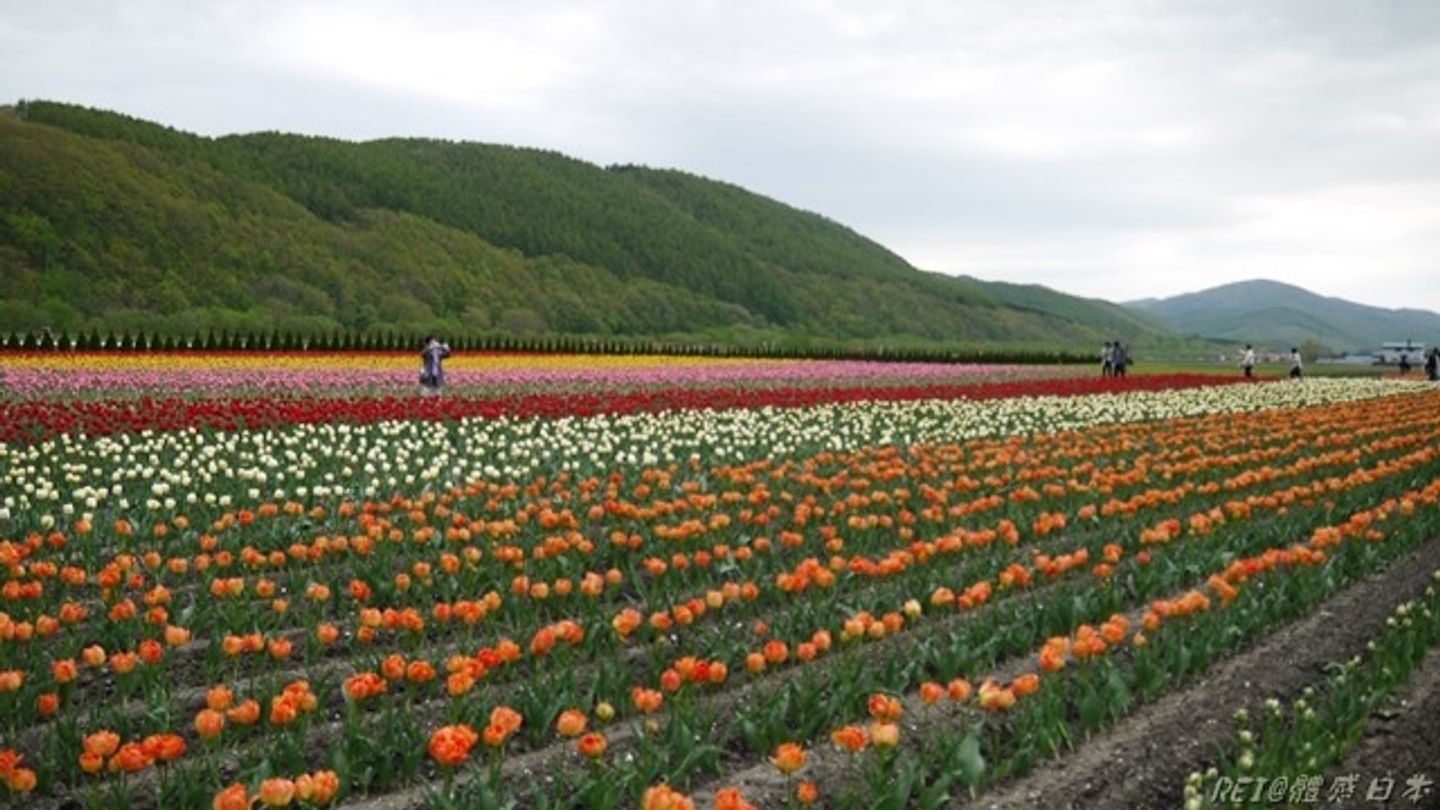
[[1325, 650, 1440, 809]]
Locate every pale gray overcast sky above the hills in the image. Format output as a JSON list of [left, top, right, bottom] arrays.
[[8, 0, 1440, 310]]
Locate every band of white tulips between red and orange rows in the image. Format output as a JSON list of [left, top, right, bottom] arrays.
[[0, 379, 1430, 538]]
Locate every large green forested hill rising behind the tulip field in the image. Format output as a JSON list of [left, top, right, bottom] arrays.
[[0, 102, 1176, 349]]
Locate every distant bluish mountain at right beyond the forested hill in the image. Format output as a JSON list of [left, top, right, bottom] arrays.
[[1126, 280, 1440, 352]]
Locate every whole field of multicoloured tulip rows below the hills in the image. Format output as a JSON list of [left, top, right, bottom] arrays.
[[0, 352, 1440, 810]]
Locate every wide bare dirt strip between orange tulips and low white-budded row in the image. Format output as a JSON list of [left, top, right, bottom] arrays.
[[975, 538, 1440, 810]]
